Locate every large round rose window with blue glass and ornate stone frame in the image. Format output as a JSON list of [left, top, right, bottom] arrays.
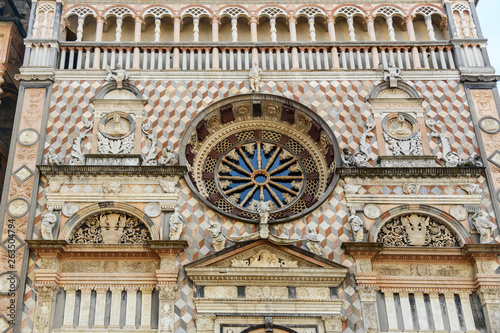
[[180, 94, 340, 223]]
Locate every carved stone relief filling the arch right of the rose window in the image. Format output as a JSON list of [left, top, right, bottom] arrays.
[[378, 214, 459, 247]]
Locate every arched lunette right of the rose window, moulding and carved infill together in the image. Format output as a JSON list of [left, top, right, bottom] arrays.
[[368, 205, 472, 247]]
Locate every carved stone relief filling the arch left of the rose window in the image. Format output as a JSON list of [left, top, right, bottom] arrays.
[[69, 212, 151, 244]]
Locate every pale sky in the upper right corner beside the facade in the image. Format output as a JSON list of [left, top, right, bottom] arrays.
[[477, 0, 500, 73]]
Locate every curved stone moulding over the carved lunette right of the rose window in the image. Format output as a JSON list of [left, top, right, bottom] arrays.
[[368, 204, 473, 246]]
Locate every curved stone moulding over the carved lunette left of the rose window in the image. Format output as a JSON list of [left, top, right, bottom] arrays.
[[59, 201, 160, 241]]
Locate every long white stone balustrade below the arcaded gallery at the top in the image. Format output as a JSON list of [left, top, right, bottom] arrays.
[[55, 43, 460, 71]]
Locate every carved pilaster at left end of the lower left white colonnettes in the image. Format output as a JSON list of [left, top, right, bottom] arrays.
[[33, 285, 59, 333]]
